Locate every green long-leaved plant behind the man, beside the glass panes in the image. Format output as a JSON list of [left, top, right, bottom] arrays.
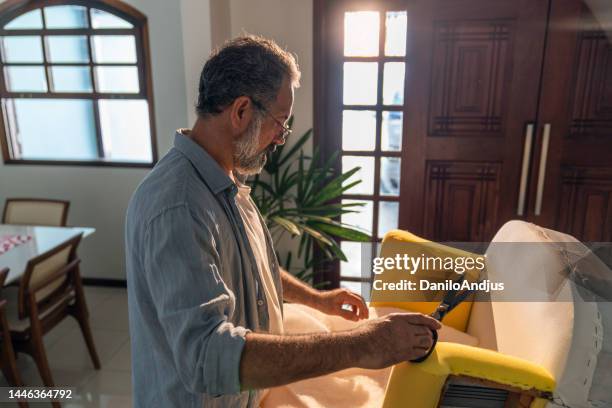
[[249, 118, 371, 282]]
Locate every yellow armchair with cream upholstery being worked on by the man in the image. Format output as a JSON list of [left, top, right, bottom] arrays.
[[370, 221, 612, 408]]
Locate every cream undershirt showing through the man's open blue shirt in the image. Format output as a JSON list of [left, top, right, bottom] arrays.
[[236, 184, 283, 334]]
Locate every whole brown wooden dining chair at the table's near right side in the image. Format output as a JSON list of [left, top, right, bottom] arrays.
[[3, 231, 100, 407]]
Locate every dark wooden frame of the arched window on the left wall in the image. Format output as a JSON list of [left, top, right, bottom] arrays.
[[0, 0, 158, 168]]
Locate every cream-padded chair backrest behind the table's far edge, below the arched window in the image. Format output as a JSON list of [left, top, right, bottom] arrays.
[[2, 198, 70, 227]]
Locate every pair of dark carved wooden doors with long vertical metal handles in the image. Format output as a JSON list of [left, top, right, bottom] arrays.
[[400, 0, 612, 241]]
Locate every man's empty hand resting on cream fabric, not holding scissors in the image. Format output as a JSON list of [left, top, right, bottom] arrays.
[[313, 289, 369, 322]]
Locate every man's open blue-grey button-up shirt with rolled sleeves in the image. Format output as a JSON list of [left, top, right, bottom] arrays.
[[125, 132, 283, 408]]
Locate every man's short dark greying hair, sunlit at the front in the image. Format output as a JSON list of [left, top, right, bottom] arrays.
[[196, 35, 300, 116]]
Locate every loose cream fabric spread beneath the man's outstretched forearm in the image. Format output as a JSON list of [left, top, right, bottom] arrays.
[[261, 304, 478, 408]]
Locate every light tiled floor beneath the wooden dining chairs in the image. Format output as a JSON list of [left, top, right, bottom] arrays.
[[0, 286, 132, 408]]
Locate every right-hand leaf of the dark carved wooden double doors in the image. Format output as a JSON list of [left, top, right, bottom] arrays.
[[529, 0, 612, 241]]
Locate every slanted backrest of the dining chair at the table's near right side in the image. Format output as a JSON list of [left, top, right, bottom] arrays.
[[18, 234, 82, 319]]
